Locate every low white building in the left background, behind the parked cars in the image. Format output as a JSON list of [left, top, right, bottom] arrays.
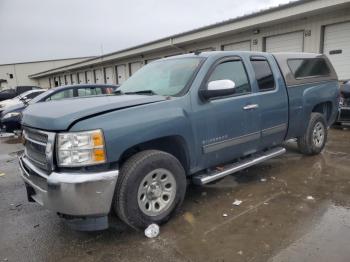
[[0, 57, 92, 89]]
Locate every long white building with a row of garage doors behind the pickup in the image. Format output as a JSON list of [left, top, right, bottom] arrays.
[[30, 0, 350, 87]]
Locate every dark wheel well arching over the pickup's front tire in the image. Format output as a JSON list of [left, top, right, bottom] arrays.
[[119, 136, 190, 173]]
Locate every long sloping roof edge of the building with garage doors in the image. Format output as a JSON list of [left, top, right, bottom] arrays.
[[29, 0, 349, 78]]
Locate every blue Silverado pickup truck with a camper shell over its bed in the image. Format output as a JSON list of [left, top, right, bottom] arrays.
[[19, 51, 339, 230]]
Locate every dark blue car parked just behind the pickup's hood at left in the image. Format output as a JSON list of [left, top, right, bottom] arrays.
[[0, 84, 115, 132]]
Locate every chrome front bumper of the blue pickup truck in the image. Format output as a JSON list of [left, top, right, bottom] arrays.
[[19, 156, 119, 217]]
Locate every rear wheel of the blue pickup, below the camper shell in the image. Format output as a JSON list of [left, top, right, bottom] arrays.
[[298, 113, 328, 155]]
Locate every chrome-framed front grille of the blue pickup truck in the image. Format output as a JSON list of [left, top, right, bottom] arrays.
[[23, 128, 54, 172]]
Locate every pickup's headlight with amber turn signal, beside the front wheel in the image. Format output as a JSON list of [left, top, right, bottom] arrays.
[[57, 130, 106, 167]]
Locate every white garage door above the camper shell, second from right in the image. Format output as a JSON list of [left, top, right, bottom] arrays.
[[265, 32, 304, 52]]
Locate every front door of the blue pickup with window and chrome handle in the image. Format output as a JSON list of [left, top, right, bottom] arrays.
[[194, 56, 260, 168]]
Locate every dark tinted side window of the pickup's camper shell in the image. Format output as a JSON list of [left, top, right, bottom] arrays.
[[287, 58, 330, 79]]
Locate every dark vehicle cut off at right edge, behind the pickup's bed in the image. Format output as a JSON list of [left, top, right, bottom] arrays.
[[335, 80, 350, 126]]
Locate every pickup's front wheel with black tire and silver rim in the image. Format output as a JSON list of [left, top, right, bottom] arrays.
[[113, 150, 187, 229]]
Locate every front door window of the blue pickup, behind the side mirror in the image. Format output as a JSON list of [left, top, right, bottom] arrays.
[[208, 60, 251, 95]]
